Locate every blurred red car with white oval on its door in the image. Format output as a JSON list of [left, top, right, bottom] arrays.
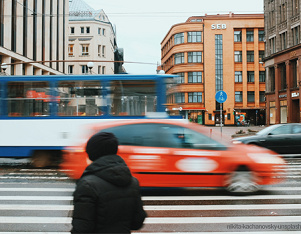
[[61, 119, 285, 193]]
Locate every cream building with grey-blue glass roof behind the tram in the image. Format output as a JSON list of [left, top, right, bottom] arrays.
[[68, 0, 117, 74]]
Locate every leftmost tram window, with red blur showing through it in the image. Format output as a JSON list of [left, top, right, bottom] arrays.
[[7, 82, 50, 117]]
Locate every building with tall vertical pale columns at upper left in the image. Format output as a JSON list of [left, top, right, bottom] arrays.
[[0, 0, 69, 75]]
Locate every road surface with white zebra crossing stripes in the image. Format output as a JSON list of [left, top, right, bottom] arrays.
[[0, 159, 301, 234]]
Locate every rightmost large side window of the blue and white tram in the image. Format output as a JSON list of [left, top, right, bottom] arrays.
[[109, 80, 157, 116]]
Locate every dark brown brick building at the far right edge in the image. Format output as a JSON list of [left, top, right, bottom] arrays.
[[264, 0, 301, 124]]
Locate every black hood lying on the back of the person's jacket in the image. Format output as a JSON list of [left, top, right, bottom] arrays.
[[82, 155, 132, 187]]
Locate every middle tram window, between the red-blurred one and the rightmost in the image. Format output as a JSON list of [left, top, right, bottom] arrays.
[[58, 81, 106, 116]]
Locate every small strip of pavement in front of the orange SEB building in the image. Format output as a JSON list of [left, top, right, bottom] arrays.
[[207, 125, 266, 138]]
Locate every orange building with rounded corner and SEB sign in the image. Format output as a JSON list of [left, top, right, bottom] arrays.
[[161, 13, 265, 125]]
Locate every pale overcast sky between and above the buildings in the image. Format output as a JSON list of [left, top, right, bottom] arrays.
[[84, 0, 263, 74]]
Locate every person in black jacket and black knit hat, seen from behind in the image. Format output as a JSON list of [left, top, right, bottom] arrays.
[[71, 132, 146, 233]]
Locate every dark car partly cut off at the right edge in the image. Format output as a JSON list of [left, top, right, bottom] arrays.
[[233, 123, 301, 155]]
